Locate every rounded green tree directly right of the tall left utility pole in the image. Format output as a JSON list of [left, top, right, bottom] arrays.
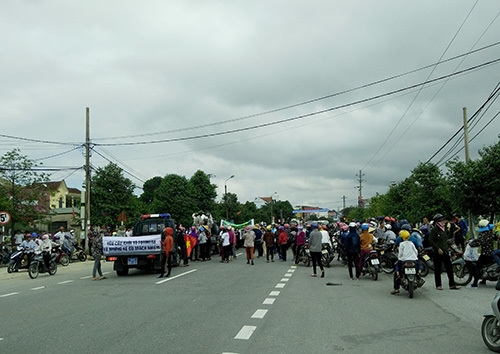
[[90, 163, 138, 226]]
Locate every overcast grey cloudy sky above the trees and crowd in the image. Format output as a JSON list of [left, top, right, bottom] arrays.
[[0, 0, 500, 209]]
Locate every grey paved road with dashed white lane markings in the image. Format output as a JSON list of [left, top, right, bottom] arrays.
[[0, 256, 495, 354]]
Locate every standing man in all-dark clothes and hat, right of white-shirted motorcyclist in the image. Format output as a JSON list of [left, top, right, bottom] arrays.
[[429, 214, 461, 290]]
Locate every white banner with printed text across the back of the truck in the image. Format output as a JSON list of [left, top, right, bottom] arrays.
[[102, 234, 161, 256]]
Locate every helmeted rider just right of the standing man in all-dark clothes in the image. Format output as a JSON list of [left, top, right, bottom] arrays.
[[467, 219, 496, 289]]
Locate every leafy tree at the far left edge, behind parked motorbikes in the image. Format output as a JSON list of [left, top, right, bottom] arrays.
[[0, 148, 50, 234]]
